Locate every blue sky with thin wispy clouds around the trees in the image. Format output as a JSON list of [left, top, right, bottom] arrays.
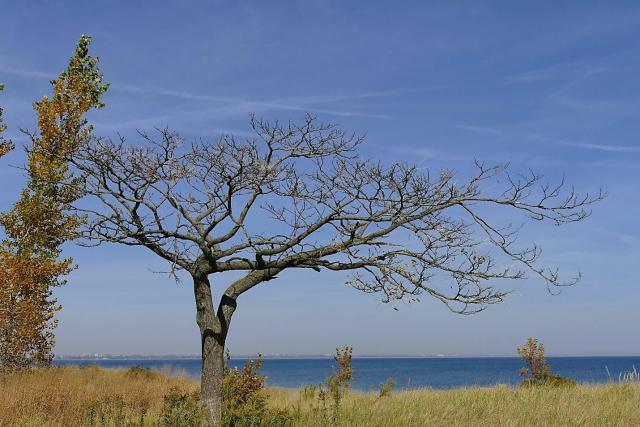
[[0, 0, 640, 355]]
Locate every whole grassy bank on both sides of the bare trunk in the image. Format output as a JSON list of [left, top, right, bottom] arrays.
[[0, 367, 640, 426]]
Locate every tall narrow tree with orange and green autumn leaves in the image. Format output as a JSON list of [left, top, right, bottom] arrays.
[[0, 36, 108, 369]]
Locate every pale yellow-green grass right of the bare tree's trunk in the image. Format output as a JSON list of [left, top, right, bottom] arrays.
[[270, 384, 640, 426]]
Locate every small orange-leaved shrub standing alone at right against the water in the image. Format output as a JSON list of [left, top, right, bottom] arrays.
[[518, 338, 576, 387]]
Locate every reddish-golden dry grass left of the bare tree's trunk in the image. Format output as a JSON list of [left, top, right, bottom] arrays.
[[0, 366, 198, 426]]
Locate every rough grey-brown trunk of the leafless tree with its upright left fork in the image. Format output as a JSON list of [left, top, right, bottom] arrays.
[[193, 274, 227, 425]]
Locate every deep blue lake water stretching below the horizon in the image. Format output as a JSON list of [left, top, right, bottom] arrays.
[[54, 356, 640, 390]]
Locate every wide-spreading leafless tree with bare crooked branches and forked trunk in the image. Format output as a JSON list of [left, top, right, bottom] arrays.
[[73, 115, 603, 422]]
